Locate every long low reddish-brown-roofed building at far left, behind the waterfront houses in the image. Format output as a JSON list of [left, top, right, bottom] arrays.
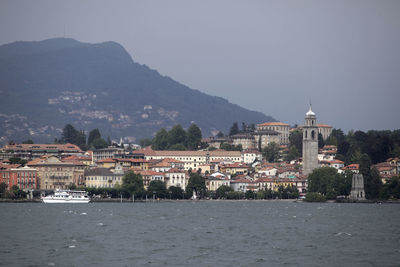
[[0, 144, 84, 160]]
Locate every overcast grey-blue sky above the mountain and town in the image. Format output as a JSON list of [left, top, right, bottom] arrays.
[[0, 0, 400, 131]]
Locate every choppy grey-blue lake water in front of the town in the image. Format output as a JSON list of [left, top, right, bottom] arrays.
[[0, 201, 400, 266]]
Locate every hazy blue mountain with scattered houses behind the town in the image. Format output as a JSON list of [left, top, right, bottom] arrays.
[[0, 38, 274, 143]]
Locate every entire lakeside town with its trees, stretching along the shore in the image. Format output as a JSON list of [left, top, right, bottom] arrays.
[[0, 106, 400, 201]]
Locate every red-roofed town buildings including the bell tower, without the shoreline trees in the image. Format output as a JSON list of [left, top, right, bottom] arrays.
[[0, 107, 400, 201]]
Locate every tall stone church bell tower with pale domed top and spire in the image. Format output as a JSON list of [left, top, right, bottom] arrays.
[[303, 105, 318, 175]]
